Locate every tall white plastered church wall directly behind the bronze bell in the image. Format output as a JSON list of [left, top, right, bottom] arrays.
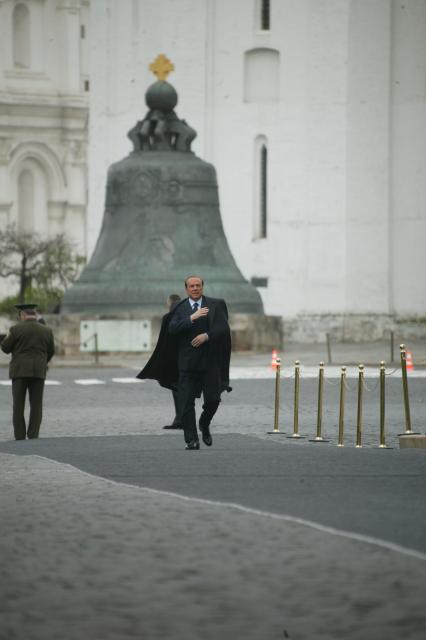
[[88, 0, 426, 335]]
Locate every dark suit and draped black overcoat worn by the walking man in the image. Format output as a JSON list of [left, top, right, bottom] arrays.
[[136, 296, 231, 442]]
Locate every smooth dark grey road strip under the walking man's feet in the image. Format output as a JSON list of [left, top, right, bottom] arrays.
[[0, 434, 426, 552]]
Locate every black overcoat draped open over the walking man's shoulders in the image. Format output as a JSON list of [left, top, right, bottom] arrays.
[[136, 296, 231, 391]]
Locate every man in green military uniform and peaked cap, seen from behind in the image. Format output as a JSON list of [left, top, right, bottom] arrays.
[[1, 303, 55, 440]]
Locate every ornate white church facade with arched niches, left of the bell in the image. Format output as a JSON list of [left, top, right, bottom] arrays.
[[0, 0, 89, 296]]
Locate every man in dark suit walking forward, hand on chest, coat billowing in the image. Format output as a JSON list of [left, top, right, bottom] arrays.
[[137, 276, 231, 450]]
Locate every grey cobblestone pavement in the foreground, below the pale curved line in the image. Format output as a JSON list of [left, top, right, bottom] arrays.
[[0, 454, 426, 640]]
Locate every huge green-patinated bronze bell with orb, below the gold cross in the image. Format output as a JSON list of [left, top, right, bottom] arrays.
[[61, 58, 263, 314]]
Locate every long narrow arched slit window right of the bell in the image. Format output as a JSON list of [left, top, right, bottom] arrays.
[[253, 136, 268, 240]]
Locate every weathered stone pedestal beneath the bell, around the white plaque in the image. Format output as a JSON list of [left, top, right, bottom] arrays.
[[36, 313, 282, 356]]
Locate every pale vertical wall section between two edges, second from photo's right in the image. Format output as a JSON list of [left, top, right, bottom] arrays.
[[345, 0, 391, 313]]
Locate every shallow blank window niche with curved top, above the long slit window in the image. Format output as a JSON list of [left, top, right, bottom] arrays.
[[244, 48, 280, 103]]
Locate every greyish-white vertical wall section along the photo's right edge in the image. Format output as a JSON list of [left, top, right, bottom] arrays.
[[391, 0, 426, 317]]
